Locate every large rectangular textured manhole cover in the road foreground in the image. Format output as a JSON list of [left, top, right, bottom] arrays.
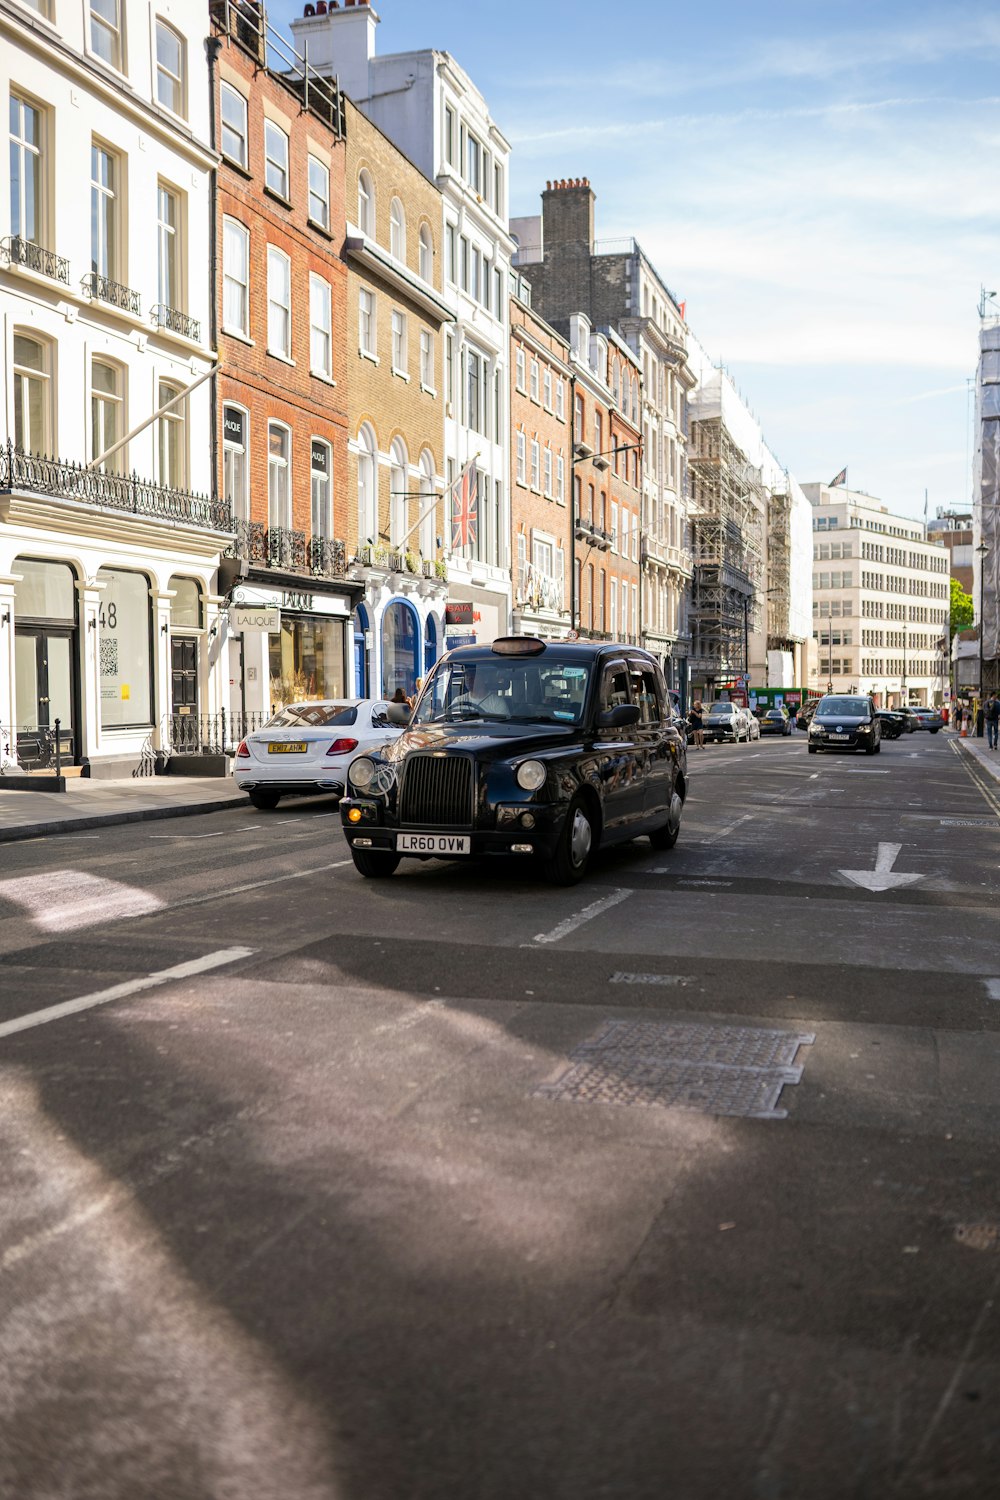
[[535, 1022, 816, 1119]]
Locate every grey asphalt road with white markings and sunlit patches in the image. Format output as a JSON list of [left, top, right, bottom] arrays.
[[0, 735, 1000, 1500]]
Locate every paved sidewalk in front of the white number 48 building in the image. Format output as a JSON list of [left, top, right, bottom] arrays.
[[0, 776, 249, 843]]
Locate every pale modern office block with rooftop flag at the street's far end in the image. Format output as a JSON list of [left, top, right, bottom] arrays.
[[802, 485, 949, 708]]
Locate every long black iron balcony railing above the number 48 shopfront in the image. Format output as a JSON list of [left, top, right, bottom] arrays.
[[0, 443, 232, 531]]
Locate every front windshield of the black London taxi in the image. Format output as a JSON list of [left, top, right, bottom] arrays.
[[411, 653, 591, 725]]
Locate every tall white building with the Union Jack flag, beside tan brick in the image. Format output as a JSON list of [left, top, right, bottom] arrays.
[[292, 5, 514, 641]]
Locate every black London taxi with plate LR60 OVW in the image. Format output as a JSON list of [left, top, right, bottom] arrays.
[[340, 636, 687, 885]]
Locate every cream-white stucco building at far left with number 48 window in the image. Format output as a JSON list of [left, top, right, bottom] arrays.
[[0, 0, 228, 776]]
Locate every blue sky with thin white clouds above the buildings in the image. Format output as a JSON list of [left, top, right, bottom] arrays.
[[271, 0, 1000, 516]]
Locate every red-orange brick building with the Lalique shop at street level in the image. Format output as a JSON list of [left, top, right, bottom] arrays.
[[211, 3, 358, 711]]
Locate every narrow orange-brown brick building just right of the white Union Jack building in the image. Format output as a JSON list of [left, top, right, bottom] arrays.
[[510, 281, 573, 641]]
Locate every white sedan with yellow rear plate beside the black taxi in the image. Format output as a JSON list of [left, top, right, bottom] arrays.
[[232, 698, 409, 809]]
